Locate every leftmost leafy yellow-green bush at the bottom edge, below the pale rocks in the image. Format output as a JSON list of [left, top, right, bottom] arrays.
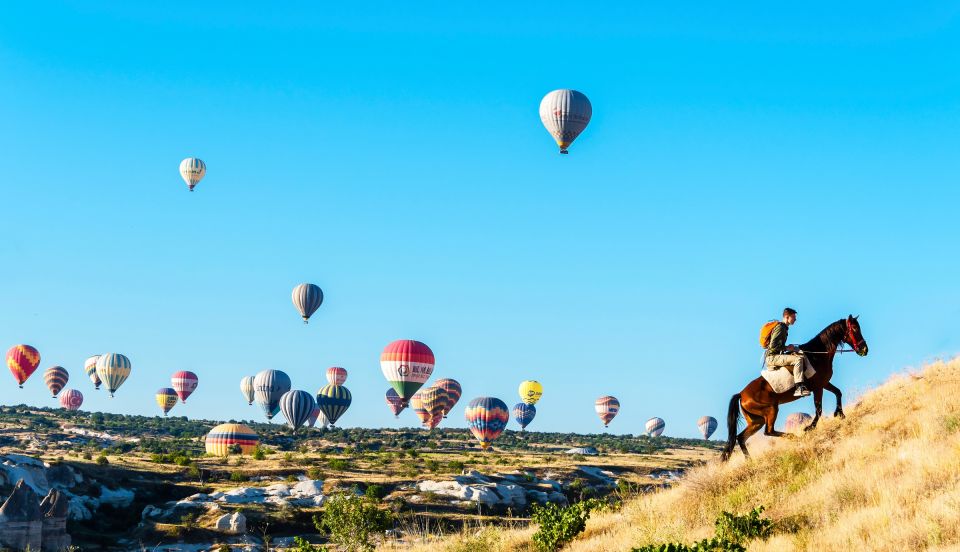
[[313, 495, 393, 552]]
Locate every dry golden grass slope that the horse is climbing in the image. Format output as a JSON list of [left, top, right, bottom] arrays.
[[414, 359, 960, 552]]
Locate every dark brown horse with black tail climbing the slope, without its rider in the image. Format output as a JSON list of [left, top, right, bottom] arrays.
[[721, 315, 867, 461]]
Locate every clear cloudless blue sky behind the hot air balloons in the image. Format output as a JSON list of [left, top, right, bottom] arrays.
[[0, 2, 960, 436]]
